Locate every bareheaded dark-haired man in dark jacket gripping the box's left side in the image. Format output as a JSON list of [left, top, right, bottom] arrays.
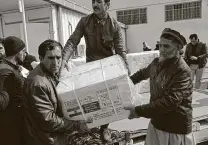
[[23, 40, 87, 145]]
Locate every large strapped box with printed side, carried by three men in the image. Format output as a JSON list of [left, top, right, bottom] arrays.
[[57, 56, 137, 128]]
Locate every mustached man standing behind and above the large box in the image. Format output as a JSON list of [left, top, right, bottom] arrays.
[[62, 0, 130, 140]]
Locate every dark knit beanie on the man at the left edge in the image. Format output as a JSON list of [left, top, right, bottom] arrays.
[[4, 36, 25, 56]]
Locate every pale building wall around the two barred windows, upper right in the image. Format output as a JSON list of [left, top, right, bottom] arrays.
[[110, 0, 208, 52]]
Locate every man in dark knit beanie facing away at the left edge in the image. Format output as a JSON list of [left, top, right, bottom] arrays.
[[0, 36, 25, 145]]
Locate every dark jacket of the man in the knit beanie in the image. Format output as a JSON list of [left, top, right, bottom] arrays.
[[0, 59, 24, 145]]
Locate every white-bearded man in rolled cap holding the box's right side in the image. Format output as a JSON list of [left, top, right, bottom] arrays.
[[125, 28, 195, 145]]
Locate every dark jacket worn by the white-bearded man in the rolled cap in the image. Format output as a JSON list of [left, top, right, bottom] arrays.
[[131, 57, 193, 134]]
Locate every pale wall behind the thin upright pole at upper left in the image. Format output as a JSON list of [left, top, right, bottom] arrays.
[[1, 6, 51, 59]]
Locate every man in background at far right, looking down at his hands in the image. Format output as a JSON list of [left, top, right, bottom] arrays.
[[185, 34, 207, 89]]
